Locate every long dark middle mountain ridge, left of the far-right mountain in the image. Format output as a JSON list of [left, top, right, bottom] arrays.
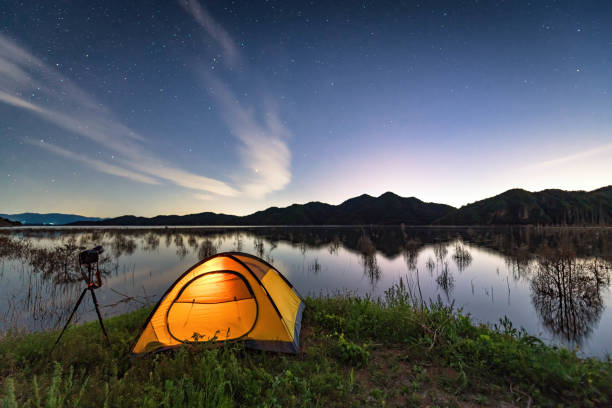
[[73, 193, 454, 226]]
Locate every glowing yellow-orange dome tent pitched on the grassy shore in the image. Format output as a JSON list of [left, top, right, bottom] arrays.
[[132, 252, 304, 354]]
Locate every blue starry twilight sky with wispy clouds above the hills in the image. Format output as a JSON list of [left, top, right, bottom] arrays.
[[0, 0, 612, 217]]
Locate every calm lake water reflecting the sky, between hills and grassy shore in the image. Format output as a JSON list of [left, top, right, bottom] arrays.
[[0, 226, 612, 357]]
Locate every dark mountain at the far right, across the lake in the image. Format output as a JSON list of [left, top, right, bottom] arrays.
[[434, 186, 612, 225]]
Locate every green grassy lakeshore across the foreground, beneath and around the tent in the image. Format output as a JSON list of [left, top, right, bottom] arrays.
[[0, 282, 612, 407]]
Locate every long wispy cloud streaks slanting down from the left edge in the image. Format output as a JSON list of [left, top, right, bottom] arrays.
[[0, 34, 239, 196]]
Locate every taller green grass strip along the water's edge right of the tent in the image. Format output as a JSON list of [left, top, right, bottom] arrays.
[[309, 281, 612, 406]]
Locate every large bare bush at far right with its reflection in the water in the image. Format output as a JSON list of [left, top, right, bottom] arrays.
[[531, 246, 610, 345]]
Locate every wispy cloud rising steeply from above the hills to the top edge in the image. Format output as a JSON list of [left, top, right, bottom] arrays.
[[180, 0, 291, 197]]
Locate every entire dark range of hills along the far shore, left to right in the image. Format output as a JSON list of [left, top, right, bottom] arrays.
[[10, 186, 612, 226]]
